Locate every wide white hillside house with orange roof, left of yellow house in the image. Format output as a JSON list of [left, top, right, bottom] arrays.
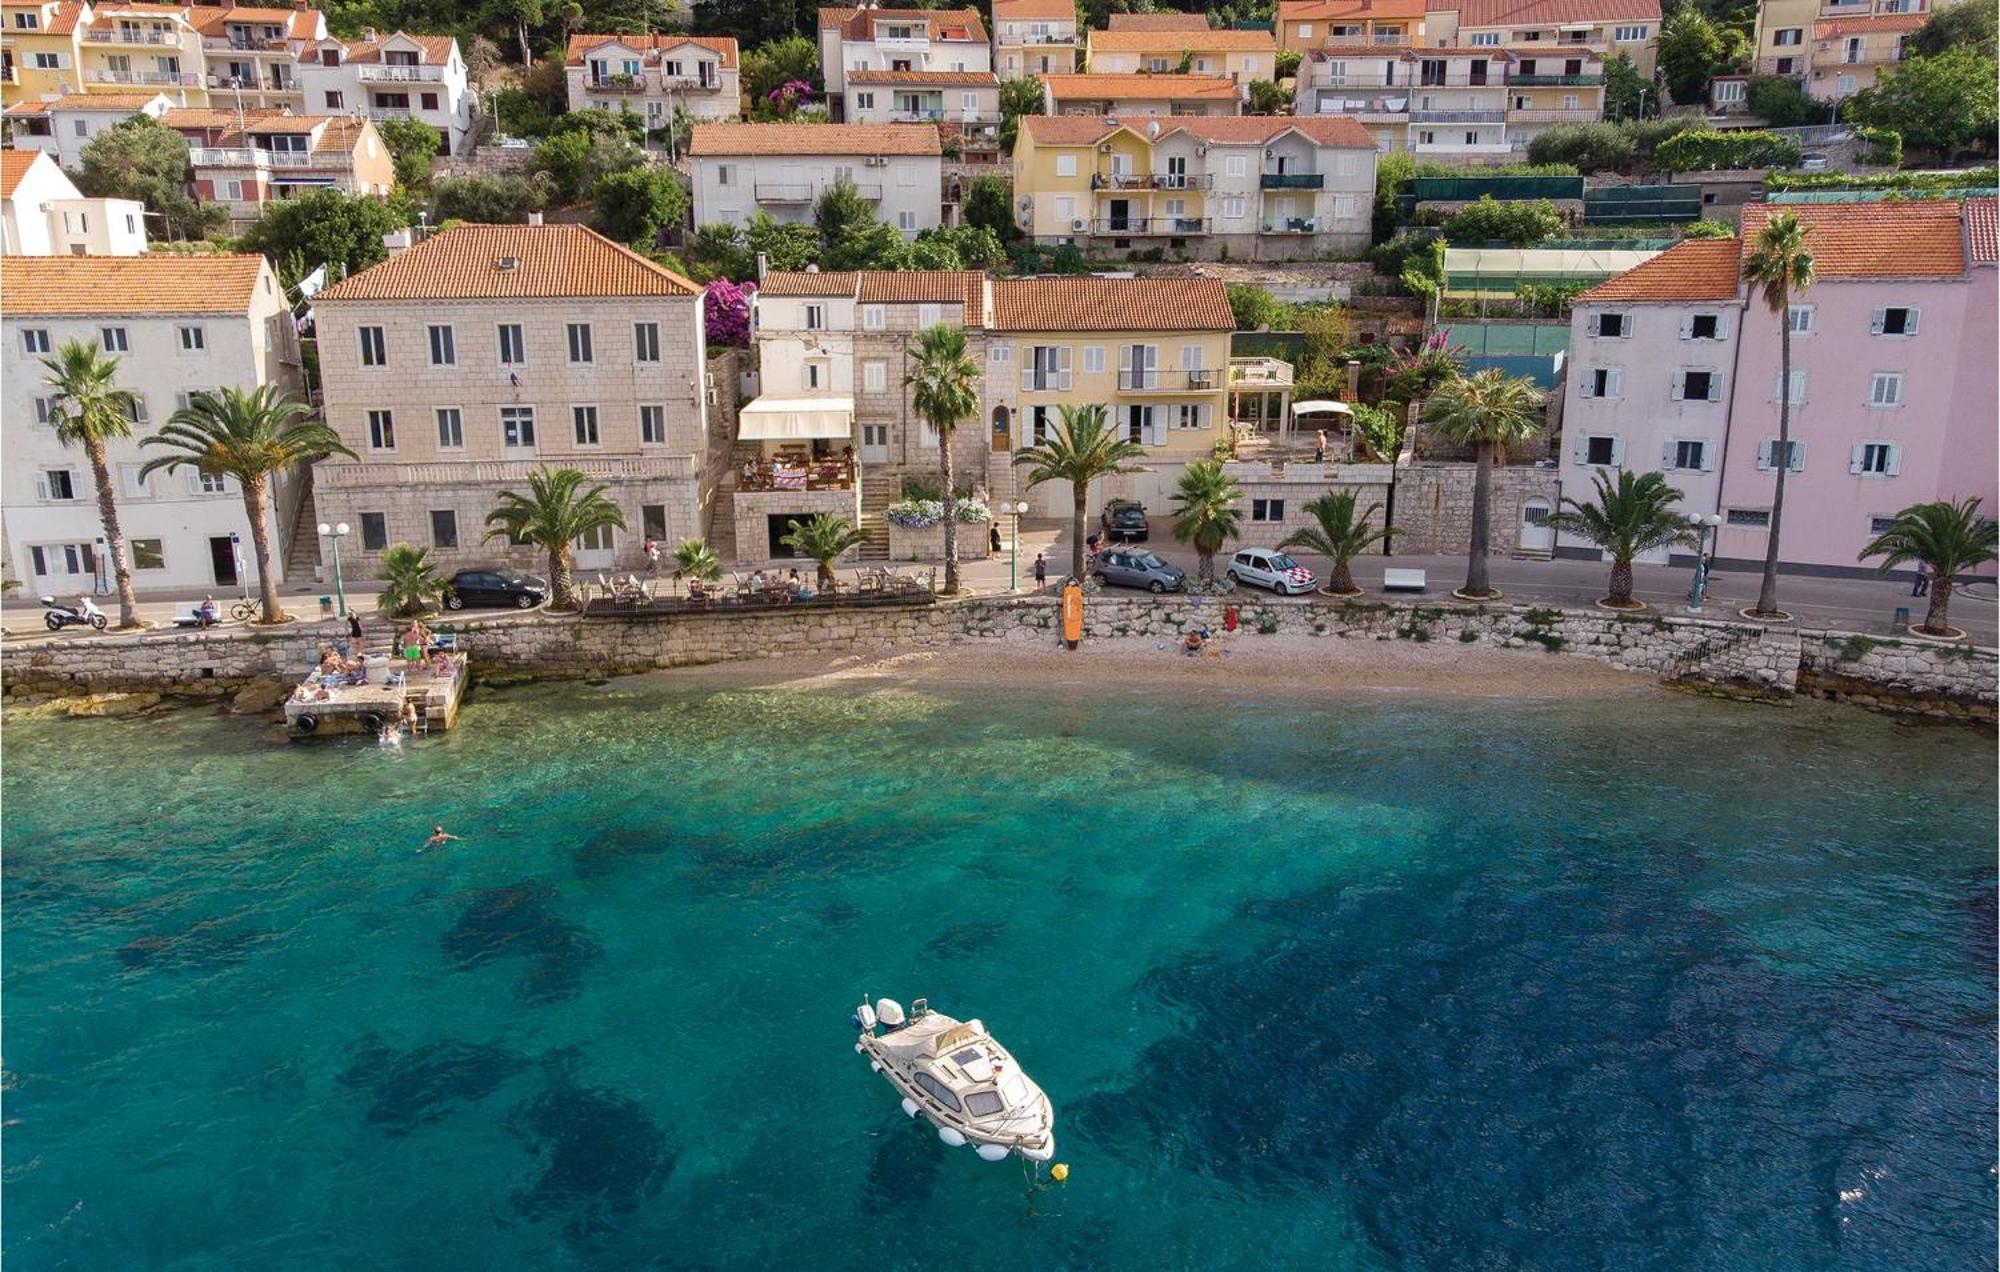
[[688, 124, 944, 238]]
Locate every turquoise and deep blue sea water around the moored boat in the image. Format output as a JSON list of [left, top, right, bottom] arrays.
[[4, 678, 1996, 1270]]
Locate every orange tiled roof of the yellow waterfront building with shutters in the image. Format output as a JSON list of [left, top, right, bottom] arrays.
[[992, 276, 1236, 332]]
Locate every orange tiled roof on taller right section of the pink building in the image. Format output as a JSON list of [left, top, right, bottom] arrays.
[[1742, 202, 1966, 282]]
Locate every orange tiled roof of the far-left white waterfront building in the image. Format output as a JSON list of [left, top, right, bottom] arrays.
[[0, 252, 266, 318]]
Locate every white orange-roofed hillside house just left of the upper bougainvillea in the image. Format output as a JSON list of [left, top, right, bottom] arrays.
[[562, 36, 742, 128]]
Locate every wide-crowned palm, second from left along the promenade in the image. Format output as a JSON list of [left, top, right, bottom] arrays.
[[138, 384, 356, 622]]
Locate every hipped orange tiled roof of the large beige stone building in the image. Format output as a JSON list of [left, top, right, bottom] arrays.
[[318, 226, 700, 304]]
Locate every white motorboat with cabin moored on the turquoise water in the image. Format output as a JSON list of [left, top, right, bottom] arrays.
[[854, 998, 1056, 1162]]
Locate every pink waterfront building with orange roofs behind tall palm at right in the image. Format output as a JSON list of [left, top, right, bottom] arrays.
[[1558, 198, 2000, 574]]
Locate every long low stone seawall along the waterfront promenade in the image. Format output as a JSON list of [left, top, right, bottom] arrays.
[[0, 592, 1996, 720]]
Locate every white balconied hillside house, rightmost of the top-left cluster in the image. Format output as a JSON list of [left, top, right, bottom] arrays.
[[298, 30, 476, 154]]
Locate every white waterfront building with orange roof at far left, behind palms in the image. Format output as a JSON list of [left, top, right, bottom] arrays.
[[0, 254, 302, 594]]
